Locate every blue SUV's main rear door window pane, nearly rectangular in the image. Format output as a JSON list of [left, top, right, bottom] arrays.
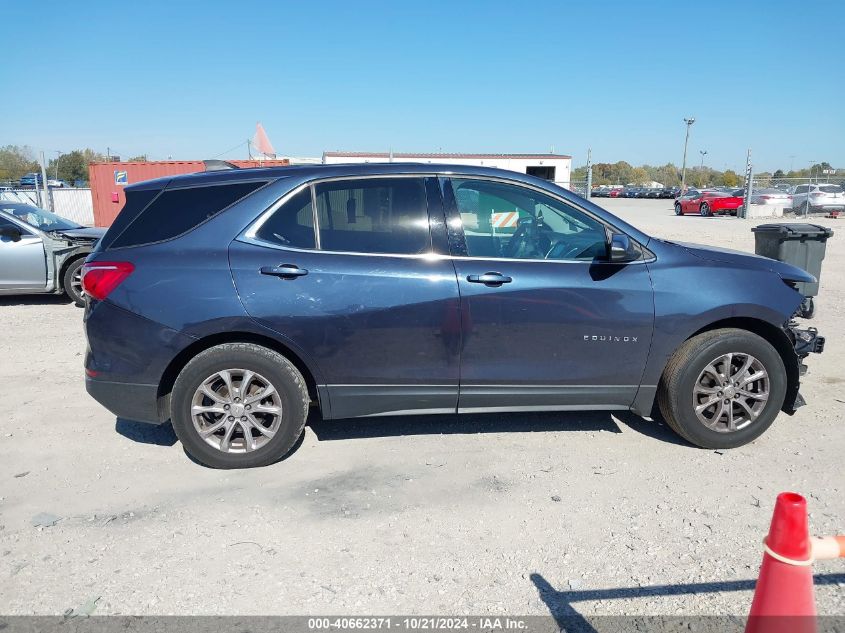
[[315, 178, 431, 255]]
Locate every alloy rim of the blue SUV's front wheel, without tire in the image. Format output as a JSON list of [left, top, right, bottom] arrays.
[[692, 353, 770, 433]]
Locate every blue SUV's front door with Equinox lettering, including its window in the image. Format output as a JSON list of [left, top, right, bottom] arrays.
[[443, 179, 654, 411]]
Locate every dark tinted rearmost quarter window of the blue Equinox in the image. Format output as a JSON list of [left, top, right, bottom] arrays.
[[111, 182, 265, 247]]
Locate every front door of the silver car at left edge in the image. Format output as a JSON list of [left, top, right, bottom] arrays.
[[0, 215, 47, 292]]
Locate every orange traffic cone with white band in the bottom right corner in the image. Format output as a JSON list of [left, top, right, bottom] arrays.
[[745, 492, 816, 633]]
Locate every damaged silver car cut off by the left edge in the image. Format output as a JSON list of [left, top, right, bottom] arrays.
[[0, 201, 105, 306]]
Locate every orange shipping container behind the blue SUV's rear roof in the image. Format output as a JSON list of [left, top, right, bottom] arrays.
[[88, 160, 290, 226]]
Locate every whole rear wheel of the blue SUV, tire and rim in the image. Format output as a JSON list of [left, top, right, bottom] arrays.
[[171, 343, 310, 468]]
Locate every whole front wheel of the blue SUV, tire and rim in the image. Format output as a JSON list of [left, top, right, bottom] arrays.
[[657, 328, 786, 448]]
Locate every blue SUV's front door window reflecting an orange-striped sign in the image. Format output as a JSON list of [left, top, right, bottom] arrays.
[[452, 179, 607, 261]]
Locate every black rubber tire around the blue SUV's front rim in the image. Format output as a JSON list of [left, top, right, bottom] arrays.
[[657, 328, 786, 448]]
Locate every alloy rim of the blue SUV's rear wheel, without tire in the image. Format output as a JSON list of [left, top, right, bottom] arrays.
[[191, 369, 282, 453]]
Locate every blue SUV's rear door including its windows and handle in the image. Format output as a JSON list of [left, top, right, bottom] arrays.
[[230, 176, 461, 418]]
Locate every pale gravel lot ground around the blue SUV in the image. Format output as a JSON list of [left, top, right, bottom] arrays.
[[0, 200, 845, 615]]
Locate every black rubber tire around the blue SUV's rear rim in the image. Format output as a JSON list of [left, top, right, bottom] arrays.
[[171, 343, 310, 469]]
